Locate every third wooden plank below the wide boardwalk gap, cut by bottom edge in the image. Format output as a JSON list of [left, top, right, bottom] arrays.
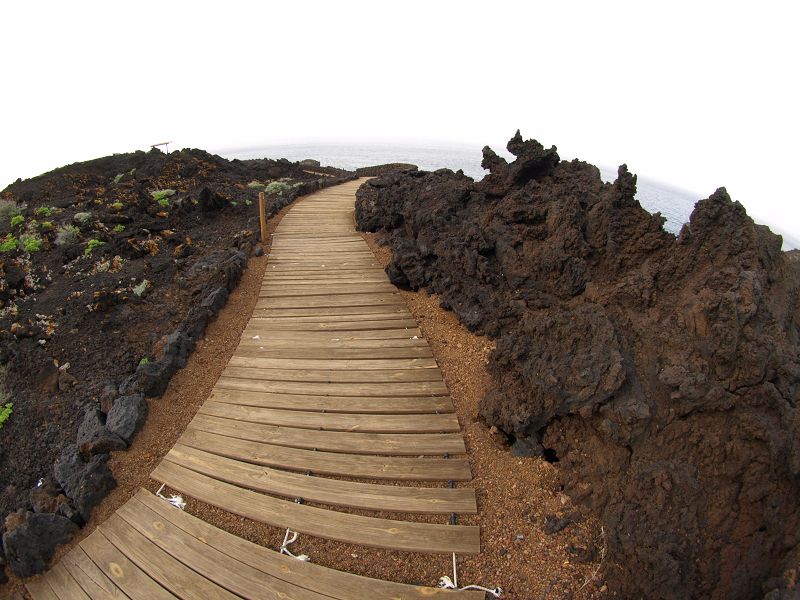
[[100, 513, 237, 600]]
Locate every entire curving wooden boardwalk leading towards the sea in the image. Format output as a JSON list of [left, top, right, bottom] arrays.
[[27, 181, 484, 600]]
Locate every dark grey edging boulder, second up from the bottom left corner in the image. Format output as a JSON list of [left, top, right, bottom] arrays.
[[53, 445, 117, 521]]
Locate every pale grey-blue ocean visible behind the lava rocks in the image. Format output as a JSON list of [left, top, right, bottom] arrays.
[[217, 143, 798, 250]]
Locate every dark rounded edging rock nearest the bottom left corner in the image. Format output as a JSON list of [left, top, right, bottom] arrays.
[[3, 512, 78, 577]]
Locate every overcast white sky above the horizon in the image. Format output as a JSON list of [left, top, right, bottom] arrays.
[[0, 0, 800, 241]]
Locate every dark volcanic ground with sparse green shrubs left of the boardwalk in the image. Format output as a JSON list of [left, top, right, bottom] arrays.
[[0, 150, 351, 556]]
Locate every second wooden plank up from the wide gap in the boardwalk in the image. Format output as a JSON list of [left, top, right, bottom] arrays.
[[164, 444, 478, 514]]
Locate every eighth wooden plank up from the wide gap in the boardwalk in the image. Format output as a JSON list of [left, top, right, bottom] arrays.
[[222, 366, 442, 384]]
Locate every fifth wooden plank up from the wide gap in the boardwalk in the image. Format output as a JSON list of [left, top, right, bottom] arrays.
[[198, 400, 461, 433]]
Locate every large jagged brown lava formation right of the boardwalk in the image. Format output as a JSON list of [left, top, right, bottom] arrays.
[[356, 132, 800, 599]]
